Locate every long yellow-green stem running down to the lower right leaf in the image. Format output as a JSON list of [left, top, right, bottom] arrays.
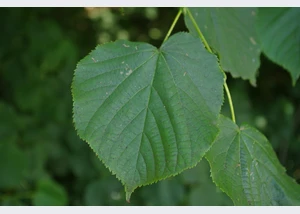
[[184, 7, 236, 123]]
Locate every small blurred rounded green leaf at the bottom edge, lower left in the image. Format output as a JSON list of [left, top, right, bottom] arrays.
[[33, 179, 68, 206]]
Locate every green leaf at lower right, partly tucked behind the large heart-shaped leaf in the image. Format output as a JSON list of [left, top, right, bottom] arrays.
[[206, 116, 300, 205]]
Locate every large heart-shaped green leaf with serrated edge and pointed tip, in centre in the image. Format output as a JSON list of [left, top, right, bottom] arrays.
[[72, 33, 224, 198]]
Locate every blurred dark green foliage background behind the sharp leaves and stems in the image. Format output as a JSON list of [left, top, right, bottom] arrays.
[[0, 8, 300, 205]]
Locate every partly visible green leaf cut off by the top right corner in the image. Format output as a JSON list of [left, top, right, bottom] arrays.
[[256, 8, 300, 85]]
